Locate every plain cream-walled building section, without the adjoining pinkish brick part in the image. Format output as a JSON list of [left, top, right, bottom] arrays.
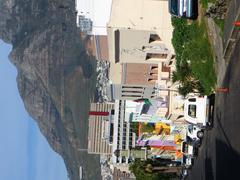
[[108, 0, 174, 63]]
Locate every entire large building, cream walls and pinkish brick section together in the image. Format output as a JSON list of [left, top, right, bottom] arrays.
[[107, 0, 182, 120]]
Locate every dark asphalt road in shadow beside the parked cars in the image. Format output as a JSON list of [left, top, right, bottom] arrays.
[[187, 35, 240, 180]]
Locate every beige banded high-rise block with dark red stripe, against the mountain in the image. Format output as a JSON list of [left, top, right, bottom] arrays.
[[88, 103, 114, 154]]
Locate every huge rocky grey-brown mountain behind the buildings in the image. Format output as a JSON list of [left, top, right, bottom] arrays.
[[0, 0, 100, 180]]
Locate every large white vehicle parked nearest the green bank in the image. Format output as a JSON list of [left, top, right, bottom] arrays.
[[184, 96, 214, 129]]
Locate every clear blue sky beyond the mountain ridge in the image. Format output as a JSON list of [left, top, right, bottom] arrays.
[[0, 40, 68, 180]]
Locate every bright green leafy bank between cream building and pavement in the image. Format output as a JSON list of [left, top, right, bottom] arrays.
[[172, 18, 216, 94]]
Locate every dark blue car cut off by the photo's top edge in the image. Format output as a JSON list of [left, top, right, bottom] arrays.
[[168, 0, 198, 19]]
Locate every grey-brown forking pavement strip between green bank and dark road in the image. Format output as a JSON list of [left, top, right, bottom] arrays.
[[206, 0, 240, 87]]
